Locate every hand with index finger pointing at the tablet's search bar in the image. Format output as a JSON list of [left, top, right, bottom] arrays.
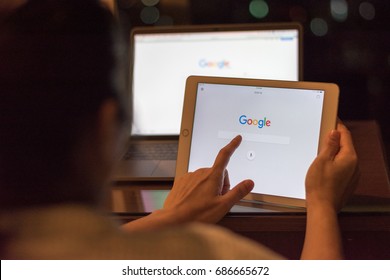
[[164, 136, 254, 223]]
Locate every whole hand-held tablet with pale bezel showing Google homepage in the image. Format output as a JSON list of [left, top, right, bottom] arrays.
[[176, 76, 339, 207]]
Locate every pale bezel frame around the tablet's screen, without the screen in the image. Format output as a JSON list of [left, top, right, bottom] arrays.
[[175, 76, 339, 207]]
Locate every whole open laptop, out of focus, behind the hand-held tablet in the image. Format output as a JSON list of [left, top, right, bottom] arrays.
[[114, 23, 303, 181]]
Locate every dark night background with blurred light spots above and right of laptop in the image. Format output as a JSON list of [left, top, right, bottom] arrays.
[[117, 0, 390, 165]]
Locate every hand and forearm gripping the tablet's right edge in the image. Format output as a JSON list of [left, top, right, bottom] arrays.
[[301, 123, 358, 259]]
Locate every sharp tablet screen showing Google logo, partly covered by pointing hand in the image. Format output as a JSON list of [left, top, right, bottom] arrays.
[[188, 83, 324, 199]]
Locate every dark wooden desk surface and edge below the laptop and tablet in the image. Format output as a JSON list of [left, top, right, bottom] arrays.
[[109, 121, 390, 259]]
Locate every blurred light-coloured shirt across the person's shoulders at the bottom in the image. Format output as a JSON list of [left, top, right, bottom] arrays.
[[0, 205, 281, 259]]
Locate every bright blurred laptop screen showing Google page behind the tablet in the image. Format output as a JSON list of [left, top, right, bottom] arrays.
[[132, 24, 301, 136]]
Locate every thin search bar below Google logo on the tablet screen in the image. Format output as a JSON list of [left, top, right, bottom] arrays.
[[218, 130, 290, 145]]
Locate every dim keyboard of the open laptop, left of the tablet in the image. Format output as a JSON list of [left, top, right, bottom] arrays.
[[124, 142, 178, 160]]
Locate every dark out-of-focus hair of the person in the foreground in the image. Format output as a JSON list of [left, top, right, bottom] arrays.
[[0, 0, 127, 207]]
